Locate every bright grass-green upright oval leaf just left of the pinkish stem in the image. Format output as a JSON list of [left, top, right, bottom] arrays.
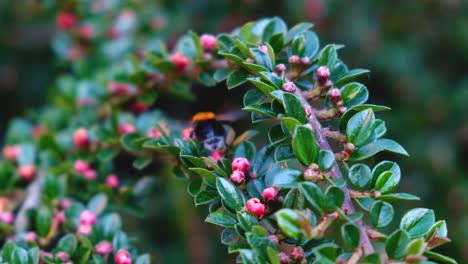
[[292, 125, 319, 166]]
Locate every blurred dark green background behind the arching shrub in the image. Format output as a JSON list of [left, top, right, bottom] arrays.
[[0, 0, 468, 263]]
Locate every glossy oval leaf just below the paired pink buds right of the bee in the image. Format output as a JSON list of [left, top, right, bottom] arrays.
[[216, 177, 245, 211]]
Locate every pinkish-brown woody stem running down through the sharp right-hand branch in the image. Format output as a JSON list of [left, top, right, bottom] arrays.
[[295, 90, 375, 255]]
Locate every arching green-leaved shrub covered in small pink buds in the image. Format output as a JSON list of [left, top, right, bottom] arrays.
[[0, 1, 456, 264]]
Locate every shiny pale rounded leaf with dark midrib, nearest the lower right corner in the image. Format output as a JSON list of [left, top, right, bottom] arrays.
[[400, 208, 435, 238]]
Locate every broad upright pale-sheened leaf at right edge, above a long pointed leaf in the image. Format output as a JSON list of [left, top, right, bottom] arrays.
[[346, 109, 375, 147]]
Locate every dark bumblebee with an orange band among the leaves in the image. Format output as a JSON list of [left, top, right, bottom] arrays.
[[191, 112, 226, 153]]
